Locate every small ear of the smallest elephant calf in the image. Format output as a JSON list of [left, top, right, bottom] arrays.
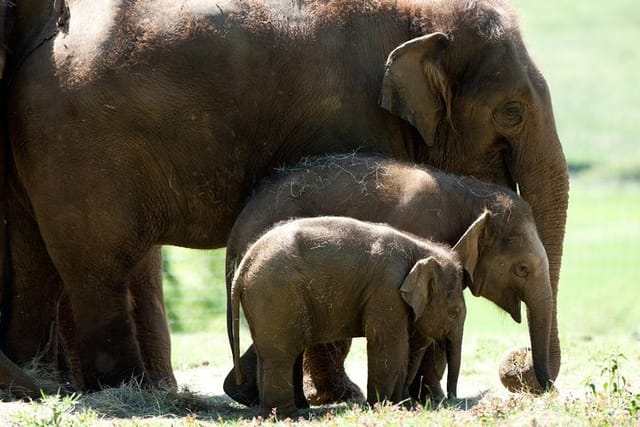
[[400, 257, 440, 320]]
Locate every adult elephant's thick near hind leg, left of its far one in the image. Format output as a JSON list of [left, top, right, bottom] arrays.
[[42, 227, 149, 390]]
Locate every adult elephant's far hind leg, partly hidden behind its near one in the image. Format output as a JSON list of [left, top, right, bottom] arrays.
[[129, 246, 177, 388]]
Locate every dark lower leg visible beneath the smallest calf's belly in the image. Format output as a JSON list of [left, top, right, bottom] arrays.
[[304, 340, 364, 405]]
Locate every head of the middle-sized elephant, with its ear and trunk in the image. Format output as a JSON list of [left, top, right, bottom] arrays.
[[454, 209, 553, 389]]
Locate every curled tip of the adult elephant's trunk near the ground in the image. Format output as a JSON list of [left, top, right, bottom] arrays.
[[499, 347, 543, 394]]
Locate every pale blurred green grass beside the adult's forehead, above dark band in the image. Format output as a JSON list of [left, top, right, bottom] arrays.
[[513, 0, 640, 180]]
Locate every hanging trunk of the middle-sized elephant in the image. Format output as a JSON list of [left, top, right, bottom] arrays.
[[524, 283, 553, 391]]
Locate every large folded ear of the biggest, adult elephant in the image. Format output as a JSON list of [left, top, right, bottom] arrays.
[[380, 33, 451, 146]]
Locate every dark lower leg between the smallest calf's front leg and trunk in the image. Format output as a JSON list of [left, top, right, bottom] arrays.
[[409, 341, 447, 405]]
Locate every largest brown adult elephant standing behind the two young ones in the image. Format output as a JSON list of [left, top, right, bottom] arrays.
[[6, 0, 568, 394]]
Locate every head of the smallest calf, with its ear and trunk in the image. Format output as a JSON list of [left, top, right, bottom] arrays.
[[400, 257, 467, 398]]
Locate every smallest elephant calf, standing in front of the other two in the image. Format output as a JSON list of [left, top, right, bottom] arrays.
[[230, 217, 466, 416]]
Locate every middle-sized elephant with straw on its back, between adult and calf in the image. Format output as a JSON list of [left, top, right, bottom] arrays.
[[224, 154, 552, 404]]
